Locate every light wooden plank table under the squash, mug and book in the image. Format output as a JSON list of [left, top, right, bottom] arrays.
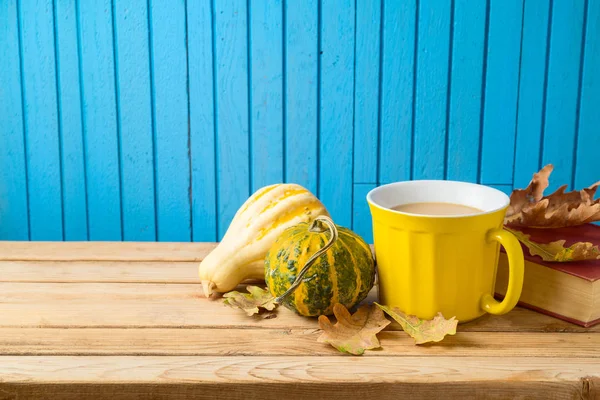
[[0, 242, 600, 400]]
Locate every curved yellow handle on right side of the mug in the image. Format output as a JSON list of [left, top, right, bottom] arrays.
[[479, 229, 524, 315]]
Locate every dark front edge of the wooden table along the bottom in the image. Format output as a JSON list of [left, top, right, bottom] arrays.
[[0, 377, 600, 400]]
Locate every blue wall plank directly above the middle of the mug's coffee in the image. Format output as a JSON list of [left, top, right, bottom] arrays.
[[412, 0, 452, 179]]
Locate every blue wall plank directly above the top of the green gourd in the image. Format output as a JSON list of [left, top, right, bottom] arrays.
[[318, 0, 355, 226]]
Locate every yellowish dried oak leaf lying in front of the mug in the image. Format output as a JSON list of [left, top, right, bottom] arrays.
[[375, 303, 458, 344]]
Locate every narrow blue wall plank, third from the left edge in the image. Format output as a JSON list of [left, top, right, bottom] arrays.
[[54, 0, 88, 240]]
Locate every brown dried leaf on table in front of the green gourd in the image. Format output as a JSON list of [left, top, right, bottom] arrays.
[[318, 304, 390, 356]]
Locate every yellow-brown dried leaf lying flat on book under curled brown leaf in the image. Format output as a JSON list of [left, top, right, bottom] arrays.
[[509, 229, 600, 262]]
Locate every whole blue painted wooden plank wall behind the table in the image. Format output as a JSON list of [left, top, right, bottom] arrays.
[[0, 0, 600, 241]]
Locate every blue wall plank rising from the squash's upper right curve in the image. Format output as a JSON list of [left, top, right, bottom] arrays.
[[284, 0, 319, 194]]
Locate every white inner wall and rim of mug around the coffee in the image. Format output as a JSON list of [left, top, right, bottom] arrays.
[[367, 180, 510, 218]]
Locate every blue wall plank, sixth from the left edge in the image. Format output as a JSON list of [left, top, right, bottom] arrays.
[[150, 0, 192, 242]]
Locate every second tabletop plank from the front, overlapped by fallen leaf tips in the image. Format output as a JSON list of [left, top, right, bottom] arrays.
[[0, 328, 600, 364]]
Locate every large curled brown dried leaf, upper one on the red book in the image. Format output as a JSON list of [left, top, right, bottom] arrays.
[[504, 164, 600, 228]]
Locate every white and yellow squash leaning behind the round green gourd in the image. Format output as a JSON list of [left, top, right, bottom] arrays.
[[199, 184, 329, 297]]
